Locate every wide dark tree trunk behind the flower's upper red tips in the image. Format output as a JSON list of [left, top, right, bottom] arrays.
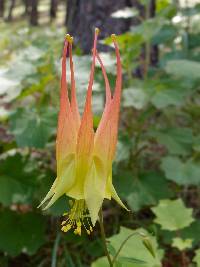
[[65, 0, 136, 53]]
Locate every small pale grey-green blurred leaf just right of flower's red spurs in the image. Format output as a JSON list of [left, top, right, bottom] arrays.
[[123, 88, 148, 109]]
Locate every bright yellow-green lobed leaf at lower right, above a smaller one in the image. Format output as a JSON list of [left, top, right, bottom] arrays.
[[152, 199, 194, 231]]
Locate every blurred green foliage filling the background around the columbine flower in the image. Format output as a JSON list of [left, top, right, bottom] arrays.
[[0, 0, 200, 267]]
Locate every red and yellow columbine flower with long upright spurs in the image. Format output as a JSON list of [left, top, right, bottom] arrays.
[[40, 29, 126, 235]]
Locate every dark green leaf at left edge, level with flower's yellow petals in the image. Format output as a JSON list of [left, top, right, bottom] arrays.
[[0, 151, 39, 206]]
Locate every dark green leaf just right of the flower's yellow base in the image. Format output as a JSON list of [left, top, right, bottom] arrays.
[[114, 171, 173, 211]]
